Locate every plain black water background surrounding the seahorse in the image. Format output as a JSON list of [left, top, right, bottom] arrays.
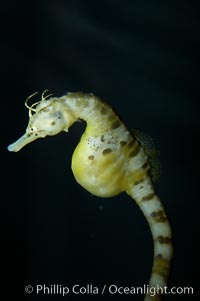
[[0, 0, 200, 300]]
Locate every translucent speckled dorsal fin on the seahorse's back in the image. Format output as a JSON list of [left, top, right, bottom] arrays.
[[132, 129, 161, 182]]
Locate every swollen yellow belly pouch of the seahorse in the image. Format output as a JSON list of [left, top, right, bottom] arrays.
[[72, 150, 125, 197]]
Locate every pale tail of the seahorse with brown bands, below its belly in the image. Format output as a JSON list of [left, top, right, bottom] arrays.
[[127, 175, 173, 301]]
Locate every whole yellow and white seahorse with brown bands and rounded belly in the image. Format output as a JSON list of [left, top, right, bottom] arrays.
[[8, 90, 173, 301]]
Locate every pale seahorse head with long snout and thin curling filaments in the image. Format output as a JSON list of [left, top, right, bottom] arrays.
[[8, 90, 69, 152]]
